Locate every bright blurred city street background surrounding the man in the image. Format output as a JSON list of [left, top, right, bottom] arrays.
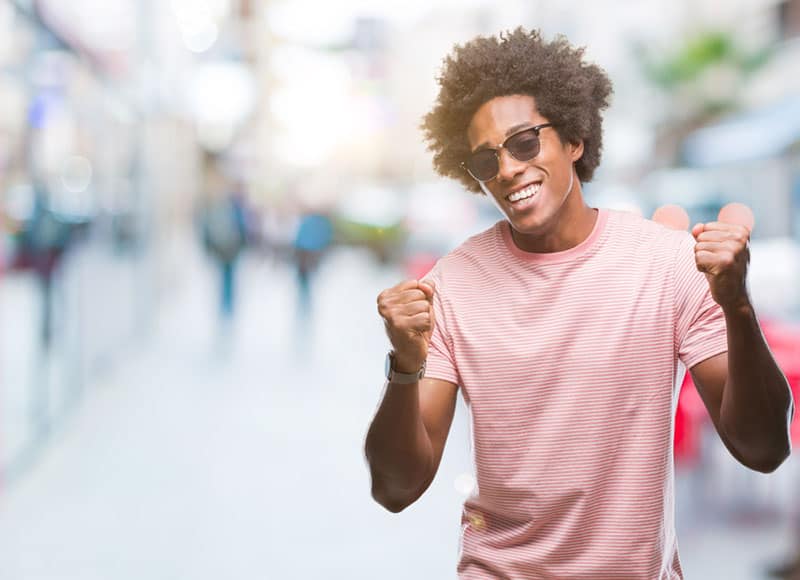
[[0, 0, 800, 580]]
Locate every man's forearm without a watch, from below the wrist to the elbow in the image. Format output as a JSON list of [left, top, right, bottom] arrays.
[[720, 303, 793, 471]]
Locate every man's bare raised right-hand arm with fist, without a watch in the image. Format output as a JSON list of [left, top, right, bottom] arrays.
[[691, 222, 794, 473]]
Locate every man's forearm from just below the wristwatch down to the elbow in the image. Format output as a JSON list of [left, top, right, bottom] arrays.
[[365, 384, 434, 511]]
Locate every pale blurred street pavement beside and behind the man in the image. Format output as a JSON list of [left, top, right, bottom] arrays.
[[0, 238, 796, 580]]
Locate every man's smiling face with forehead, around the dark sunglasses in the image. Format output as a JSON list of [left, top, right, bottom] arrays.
[[467, 95, 583, 239]]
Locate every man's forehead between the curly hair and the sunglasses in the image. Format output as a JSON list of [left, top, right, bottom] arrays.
[[467, 95, 546, 148]]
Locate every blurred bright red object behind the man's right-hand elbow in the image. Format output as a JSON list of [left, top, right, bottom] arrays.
[[675, 320, 800, 466]]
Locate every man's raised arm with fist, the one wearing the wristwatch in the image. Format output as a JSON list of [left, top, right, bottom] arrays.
[[364, 280, 458, 512]]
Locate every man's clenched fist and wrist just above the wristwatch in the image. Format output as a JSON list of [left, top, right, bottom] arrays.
[[378, 280, 435, 373]]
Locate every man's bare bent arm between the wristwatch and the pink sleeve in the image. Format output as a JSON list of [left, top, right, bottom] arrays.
[[364, 378, 457, 512]]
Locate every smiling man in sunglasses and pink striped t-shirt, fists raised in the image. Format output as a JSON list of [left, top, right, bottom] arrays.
[[365, 29, 793, 580]]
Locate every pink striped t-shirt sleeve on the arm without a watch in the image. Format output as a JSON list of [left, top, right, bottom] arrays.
[[675, 235, 728, 369]]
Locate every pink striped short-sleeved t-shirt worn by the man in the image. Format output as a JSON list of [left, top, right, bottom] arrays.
[[426, 209, 727, 580]]
